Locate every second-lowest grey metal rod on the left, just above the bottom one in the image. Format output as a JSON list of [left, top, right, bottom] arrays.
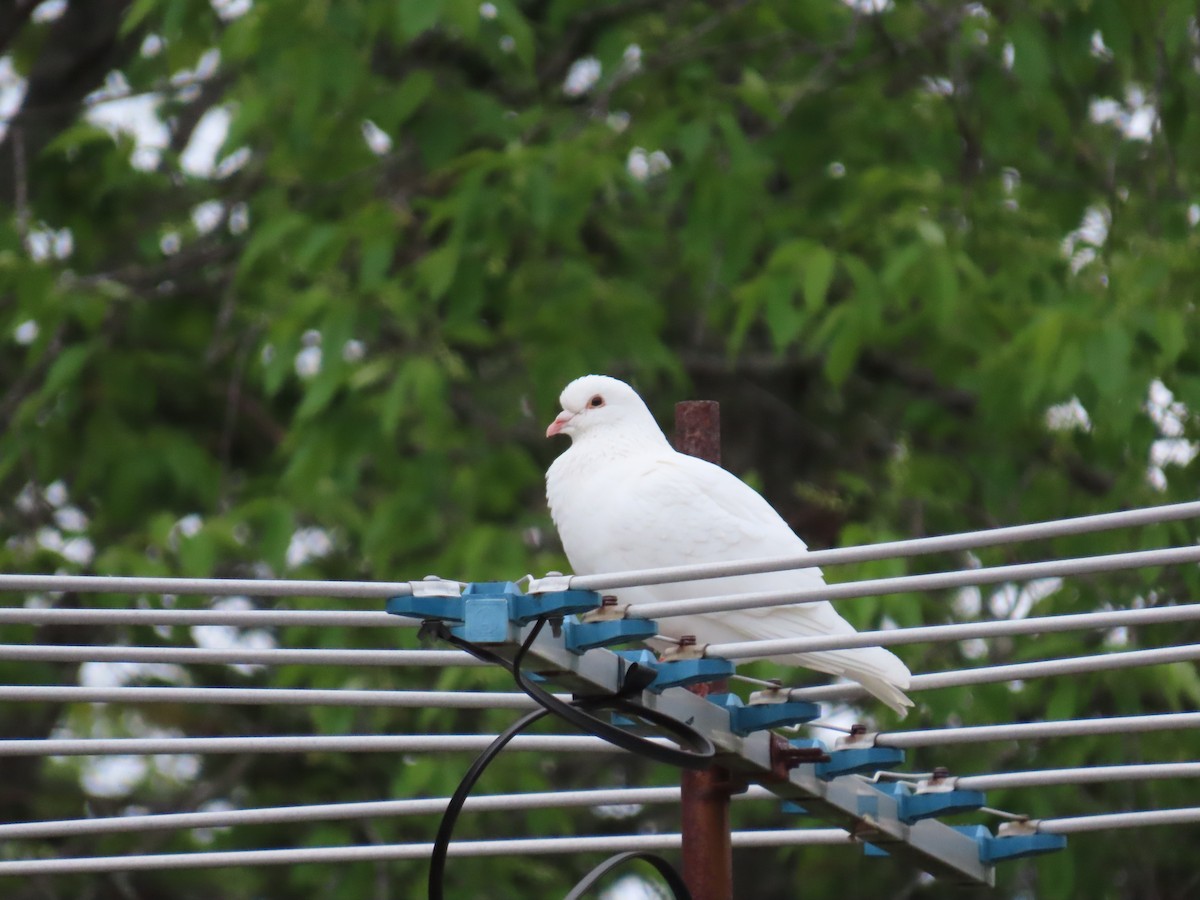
[[0, 785, 775, 840]]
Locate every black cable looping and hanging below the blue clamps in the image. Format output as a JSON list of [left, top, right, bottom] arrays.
[[428, 618, 716, 900]]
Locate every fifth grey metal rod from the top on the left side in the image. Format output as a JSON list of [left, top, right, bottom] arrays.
[[0, 734, 652, 757]]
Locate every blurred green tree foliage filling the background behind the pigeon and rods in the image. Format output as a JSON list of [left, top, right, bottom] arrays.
[[0, 0, 1200, 898]]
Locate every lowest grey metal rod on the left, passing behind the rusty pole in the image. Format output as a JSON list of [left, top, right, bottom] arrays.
[[0, 828, 854, 876]]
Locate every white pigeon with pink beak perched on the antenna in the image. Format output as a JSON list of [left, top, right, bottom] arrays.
[[546, 374, 912, 714]]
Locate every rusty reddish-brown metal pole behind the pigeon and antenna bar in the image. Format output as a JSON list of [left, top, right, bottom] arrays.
[[674, 400, 733, 900]]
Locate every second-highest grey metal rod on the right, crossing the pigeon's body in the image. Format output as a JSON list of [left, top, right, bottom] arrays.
[[625, 546, 1200, 619]]
